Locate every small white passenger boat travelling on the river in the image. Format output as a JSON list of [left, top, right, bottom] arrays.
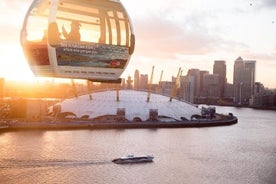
[[112, 155, 154, 164]]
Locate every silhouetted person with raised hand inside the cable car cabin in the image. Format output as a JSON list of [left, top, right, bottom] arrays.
[[62, 20, 81, 41]]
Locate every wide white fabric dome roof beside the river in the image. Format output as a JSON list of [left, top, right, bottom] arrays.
[[52, 90, 200, 121]]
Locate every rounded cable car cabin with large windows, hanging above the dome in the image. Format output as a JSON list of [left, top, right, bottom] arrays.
[[21, 0, 135, 82]]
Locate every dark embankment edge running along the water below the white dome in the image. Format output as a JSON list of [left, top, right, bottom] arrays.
[[0, 113, 238, 131]]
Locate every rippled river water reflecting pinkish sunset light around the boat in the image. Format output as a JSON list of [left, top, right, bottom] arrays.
[[0, 107, 276, 184]]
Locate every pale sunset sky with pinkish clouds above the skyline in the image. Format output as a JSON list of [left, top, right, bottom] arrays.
[[0, 0, 276, 88]]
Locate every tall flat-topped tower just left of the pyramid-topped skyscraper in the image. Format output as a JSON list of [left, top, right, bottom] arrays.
[[213, 60, 227, 98]]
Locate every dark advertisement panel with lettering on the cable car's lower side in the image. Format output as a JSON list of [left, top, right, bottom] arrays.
[[56, 41, 129, 69]]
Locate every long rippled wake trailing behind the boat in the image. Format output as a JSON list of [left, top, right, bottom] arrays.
[[0, 159, 112, 169]]
